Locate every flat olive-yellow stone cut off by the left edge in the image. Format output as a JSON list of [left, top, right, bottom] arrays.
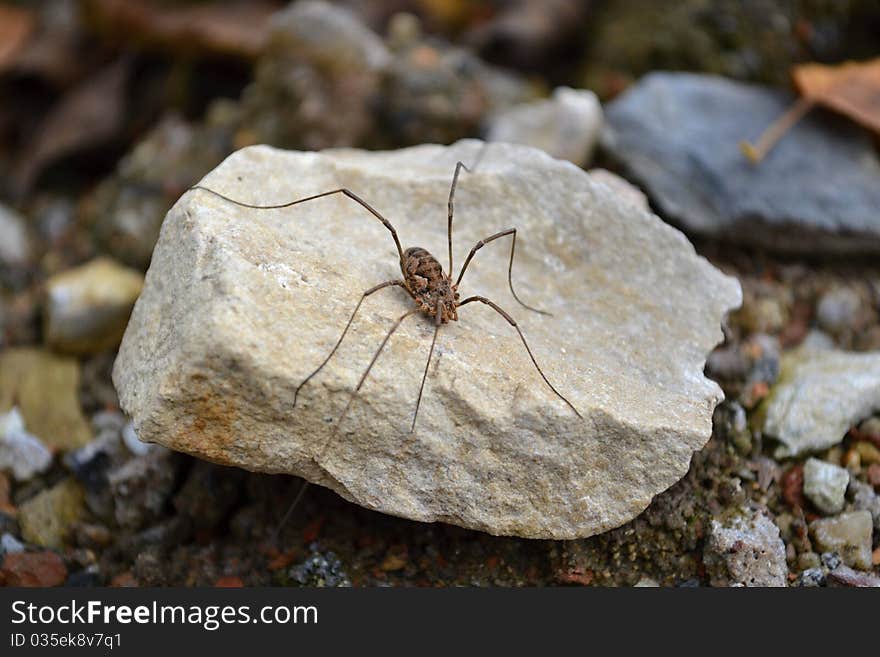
[[0, 347, 92, 450]]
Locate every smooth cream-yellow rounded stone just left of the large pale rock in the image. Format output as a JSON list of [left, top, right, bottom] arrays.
[[44, 257, 144, 354]]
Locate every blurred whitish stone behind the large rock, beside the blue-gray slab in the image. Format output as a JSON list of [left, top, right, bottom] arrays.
[[486, 87, 602, 167]]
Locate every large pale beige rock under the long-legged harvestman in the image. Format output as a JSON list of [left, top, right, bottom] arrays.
[[114, 141, 741, 538]]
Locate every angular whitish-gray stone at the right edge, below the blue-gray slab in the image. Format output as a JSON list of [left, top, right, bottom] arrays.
[[764, 345, 880, 458]]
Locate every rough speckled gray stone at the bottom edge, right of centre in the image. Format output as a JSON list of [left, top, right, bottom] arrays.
[[703, 509, 788, 586]]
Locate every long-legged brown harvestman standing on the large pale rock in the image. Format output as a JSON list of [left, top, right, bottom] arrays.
[[187, 154, 581, 529]]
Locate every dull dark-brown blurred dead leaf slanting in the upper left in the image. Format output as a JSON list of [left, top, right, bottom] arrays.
[[15, 59, 130, 193]]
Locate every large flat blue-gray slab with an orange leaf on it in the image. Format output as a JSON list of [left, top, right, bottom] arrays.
[[603, 73, 880, 254]]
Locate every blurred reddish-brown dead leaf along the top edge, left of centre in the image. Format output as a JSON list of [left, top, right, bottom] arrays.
[[86, 0, 278, 58]]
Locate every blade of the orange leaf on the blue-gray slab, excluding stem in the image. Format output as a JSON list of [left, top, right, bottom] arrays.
[[791, 57, 880, 134]]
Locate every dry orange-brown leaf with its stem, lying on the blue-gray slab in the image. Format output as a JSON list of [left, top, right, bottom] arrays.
[[740, 57, 880, 164]]
